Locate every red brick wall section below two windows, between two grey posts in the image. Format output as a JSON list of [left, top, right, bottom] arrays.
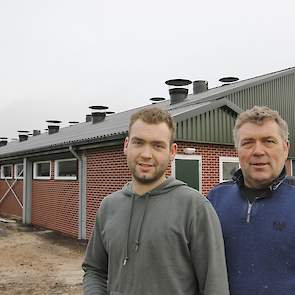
[[32, 162, 79, 237]]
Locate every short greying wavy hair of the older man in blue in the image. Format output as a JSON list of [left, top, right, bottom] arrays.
[[233, 106, 289, 147]]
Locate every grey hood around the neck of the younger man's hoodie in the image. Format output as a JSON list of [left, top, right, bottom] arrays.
[[122, 176, 187, 198]]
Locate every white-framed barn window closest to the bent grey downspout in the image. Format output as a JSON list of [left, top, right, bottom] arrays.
[[54, 159, 78, 180]]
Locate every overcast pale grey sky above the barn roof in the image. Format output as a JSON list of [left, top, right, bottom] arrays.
[[0, 0, 295, 138]]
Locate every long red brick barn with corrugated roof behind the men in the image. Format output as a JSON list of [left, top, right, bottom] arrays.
[[0, 68, 295, 239]]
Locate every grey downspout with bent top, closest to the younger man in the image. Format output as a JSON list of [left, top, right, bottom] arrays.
[[69, 145, 86, 240]]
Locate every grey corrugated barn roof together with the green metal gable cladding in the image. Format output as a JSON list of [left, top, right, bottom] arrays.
[[0, 68, 295, 158]]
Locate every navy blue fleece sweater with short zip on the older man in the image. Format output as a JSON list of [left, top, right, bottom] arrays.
[[208, 171, 295, 295]]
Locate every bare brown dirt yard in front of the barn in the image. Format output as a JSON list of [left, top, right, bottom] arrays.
[[0, 216, 86, 295]]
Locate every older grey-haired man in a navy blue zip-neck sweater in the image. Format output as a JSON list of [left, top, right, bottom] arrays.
[[208, 107, 295, 295]]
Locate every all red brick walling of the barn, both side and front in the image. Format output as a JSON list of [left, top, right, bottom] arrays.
[[0, 142, 290, 238]]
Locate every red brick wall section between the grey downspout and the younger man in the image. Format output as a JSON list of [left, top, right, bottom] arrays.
[[86, 145, 131, 238]]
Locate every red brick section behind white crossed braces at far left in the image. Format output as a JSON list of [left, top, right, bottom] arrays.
[[0, 179, 23, 218]]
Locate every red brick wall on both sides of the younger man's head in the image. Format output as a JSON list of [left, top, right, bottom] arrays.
[[86, 143, 236, 238]]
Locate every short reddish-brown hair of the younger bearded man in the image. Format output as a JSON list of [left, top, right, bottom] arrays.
[[128, 107, 176, 143]]
